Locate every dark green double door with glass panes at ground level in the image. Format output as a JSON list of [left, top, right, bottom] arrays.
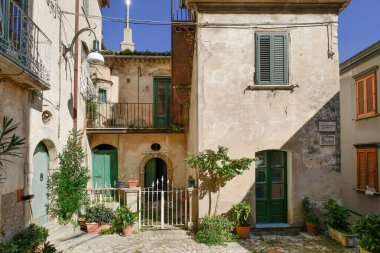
[[256, 151, 287, 223]]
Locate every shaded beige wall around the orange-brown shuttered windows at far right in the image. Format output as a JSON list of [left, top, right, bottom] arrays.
[[340, 52, 380, 215]]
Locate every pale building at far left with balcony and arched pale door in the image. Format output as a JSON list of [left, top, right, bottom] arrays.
[[0, 0, 109, 239]]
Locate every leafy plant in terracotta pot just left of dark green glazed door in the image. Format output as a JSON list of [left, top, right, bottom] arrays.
[[229, 202, 252, 239]]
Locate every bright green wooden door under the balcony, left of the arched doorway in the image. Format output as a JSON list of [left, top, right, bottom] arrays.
[[92, 150, 118, 188]]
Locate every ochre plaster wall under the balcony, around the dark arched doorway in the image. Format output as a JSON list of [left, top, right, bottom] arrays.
[[89, 133, 187, 187]]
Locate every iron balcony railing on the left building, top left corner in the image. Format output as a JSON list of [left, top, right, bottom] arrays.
[[0, 0, 52, 84]]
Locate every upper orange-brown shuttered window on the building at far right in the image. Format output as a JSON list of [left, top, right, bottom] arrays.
[[356, 72, 377, 118]]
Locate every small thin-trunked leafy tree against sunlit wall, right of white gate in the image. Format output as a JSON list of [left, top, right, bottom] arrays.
[[185, 146, 256, 214]]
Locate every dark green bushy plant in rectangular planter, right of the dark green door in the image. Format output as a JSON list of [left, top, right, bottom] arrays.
[[322, 199, 350, 232]]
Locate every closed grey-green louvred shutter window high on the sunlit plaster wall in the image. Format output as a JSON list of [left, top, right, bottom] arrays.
[[256, 32, 289, 85]]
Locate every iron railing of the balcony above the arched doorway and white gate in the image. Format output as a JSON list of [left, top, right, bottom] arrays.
[[86, 102, 184, 131]]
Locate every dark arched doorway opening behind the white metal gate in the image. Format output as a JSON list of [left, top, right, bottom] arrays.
[[144, 158, 168, 190]]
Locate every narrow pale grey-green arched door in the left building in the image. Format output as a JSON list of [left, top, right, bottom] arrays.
[[32, 142, 49, 225]]
